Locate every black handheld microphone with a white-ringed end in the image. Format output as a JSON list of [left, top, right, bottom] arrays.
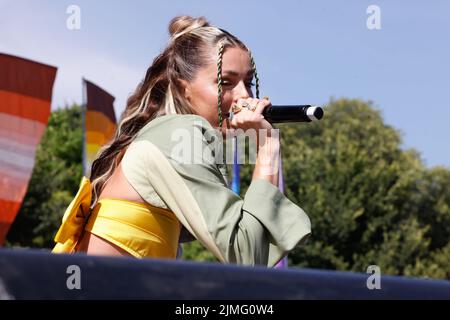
[[262, 104, 323, 123]]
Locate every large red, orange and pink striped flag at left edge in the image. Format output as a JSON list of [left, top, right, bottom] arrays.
[[0, 53, 57, 245]]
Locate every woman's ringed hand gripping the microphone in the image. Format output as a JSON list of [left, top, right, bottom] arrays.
[[229, 98, 273, 134]]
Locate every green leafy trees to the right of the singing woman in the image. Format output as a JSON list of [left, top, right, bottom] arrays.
[[242, 99, 450, 278]]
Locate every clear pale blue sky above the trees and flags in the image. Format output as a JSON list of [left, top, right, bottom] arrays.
[[0, 0, 450, 168]]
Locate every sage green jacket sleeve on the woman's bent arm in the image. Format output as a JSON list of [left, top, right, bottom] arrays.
[[139, 116, 311, 266]]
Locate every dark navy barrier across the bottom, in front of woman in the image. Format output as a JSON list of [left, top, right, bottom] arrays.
[[0, 249, 450, 300]]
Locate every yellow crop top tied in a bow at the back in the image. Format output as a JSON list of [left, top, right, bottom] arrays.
[[52, 177, 181, 259]]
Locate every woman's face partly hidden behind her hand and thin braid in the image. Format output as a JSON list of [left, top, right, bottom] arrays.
[[185, 47, 253, 132]]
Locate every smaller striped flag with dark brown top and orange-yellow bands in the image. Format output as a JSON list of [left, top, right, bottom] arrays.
[[83, 79, 117, 177]]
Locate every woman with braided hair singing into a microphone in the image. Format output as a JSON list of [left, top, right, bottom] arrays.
[[53, 16, 310, 266]]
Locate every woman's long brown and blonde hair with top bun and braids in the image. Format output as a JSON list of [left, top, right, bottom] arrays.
[[90, 16, 259, 207]]
